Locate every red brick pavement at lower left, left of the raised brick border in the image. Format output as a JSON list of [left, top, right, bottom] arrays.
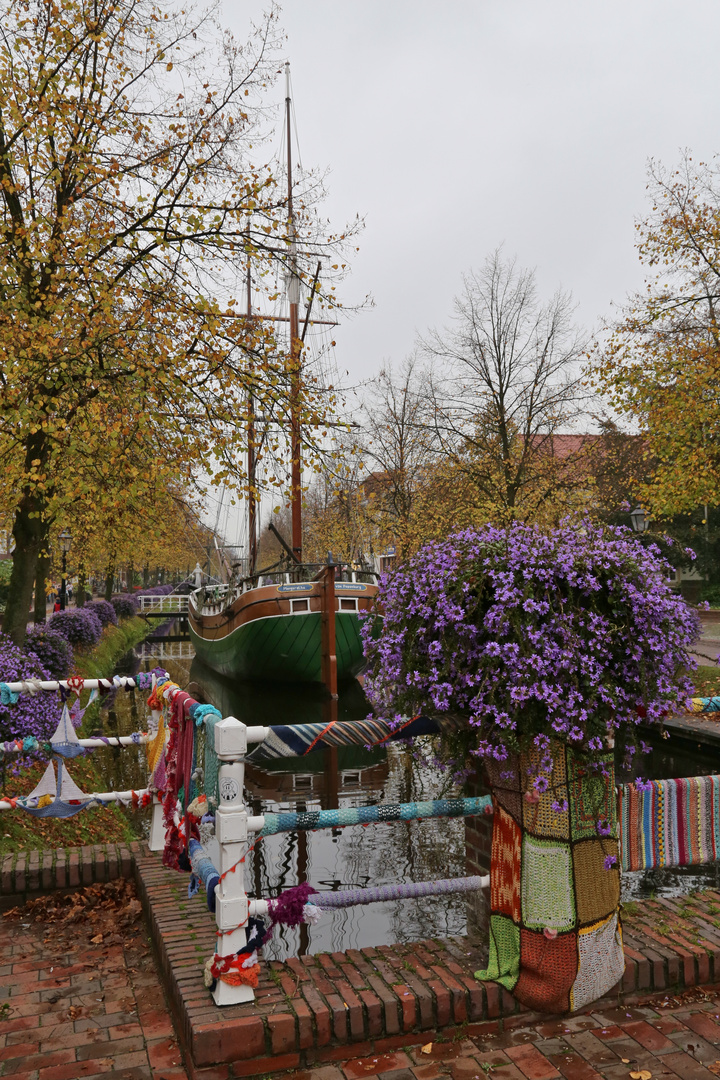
[[0, 882, 188, 1080]]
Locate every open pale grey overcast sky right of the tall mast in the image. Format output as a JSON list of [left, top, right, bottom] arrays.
[[218, 0, 720, 381]]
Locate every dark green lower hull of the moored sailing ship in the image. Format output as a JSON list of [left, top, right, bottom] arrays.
[[189, 611, 365, 683]]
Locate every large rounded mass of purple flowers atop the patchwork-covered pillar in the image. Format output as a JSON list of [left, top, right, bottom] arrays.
[[362, 522, 699, 772]]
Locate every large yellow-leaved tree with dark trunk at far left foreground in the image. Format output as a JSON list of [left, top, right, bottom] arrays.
[[0, 0, 354, 642]]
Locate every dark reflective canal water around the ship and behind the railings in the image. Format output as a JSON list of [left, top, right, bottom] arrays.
[[95, 624, 720, 959]]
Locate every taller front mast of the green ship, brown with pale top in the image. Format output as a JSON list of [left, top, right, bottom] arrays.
[[285, 60, 302, 563]]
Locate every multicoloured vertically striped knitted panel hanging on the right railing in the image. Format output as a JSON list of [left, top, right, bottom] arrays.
[[620, 777, 720, 870]]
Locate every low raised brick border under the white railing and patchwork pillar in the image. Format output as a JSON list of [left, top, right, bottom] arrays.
[[136, 856, 720, 1080]]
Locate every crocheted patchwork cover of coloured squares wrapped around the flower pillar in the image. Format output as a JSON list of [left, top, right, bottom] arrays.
[[476, 745, 625, 1013]]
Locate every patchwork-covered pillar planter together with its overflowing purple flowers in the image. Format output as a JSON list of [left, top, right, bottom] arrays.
[[364, 522, 699, 1012]]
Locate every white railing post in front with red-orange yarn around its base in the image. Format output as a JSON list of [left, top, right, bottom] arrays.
[[213, 716, 255, 1005]]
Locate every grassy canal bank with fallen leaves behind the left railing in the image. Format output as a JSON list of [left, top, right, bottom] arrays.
[[0, 616, 148, 854]]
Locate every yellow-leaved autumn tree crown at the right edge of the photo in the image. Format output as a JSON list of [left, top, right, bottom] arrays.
[[590, 154, 720, 516]]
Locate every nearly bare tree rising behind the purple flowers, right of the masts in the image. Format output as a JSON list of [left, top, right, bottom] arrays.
[[423, 251, 588, 523]]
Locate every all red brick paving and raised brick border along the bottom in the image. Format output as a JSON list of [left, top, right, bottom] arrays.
[[9, 849, 720, 1080]]
